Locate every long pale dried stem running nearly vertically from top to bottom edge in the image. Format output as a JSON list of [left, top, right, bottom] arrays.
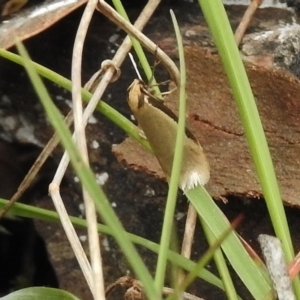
[[71, 0, 105, 300]]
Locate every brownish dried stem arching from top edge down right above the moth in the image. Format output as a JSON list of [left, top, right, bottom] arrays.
[[98, 0, 180, 86]]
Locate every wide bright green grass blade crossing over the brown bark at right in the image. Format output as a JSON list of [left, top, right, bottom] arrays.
[[199, 0, 300, 299]]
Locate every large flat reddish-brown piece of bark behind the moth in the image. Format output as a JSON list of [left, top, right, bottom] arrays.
[[113, 46, 300, 206]]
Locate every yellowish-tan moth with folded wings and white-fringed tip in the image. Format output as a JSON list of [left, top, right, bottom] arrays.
[[127, 79, 210, 191]]
